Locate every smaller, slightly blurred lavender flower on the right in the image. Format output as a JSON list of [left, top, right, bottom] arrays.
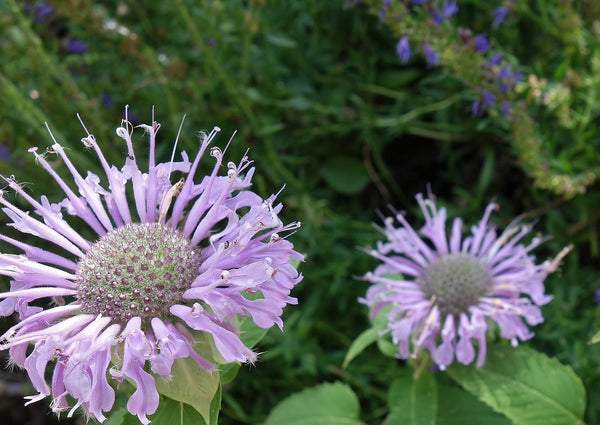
[[361, 195, 569, 370]]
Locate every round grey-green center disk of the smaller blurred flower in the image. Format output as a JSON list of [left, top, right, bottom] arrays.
[[419, 253, 492, 316]]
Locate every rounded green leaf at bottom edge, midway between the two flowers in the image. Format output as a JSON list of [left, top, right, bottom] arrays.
[[264, 382, 361, 425]]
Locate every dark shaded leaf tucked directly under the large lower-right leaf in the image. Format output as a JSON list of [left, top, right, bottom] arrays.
[[436, 385, 511, 425]]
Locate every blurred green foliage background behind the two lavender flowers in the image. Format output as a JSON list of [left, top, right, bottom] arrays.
[[0, 0, 600, 424]]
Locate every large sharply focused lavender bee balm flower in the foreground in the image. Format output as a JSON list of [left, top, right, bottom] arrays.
[[0, 108, 302, 424]]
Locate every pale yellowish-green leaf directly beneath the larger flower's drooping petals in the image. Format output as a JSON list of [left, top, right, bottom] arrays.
[[156, 357, 220, 423]]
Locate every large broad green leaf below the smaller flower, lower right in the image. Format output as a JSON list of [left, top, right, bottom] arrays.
[[447, 346, 585, 425]]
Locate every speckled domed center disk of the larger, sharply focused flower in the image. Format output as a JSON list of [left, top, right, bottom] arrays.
[[76, 223, 200, 323]]
